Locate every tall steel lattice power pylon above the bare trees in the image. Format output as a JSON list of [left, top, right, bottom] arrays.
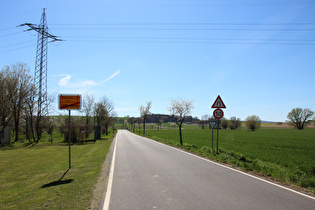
[[19, 9, 62, 115]]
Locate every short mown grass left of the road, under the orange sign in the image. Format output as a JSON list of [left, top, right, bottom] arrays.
[[0, 140, 111, 209]]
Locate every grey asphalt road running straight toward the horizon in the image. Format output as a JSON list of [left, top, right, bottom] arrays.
[[104, 130, 315, 210]]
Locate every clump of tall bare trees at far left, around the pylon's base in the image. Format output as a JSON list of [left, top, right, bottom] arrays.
[[0, 62, 53, 142]]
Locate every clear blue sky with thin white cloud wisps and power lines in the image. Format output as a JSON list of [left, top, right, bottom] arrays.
[[0, 0, 315, 121]]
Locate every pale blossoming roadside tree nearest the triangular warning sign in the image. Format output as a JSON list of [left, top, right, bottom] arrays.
[[169, 98, 194, 145]]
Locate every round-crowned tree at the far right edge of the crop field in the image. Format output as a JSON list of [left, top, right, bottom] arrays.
[[287, 108, 314, 130]]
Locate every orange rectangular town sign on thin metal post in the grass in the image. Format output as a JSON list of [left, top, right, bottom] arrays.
[[59, 94, 81, 169]]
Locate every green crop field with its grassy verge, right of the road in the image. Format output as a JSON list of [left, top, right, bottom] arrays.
[[146, 126, 315, 193]]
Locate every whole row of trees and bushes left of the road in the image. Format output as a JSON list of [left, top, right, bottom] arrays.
[[0, 62, 117, 144]]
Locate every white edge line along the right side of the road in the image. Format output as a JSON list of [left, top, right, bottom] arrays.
[[134, 134, 315, 200]]
